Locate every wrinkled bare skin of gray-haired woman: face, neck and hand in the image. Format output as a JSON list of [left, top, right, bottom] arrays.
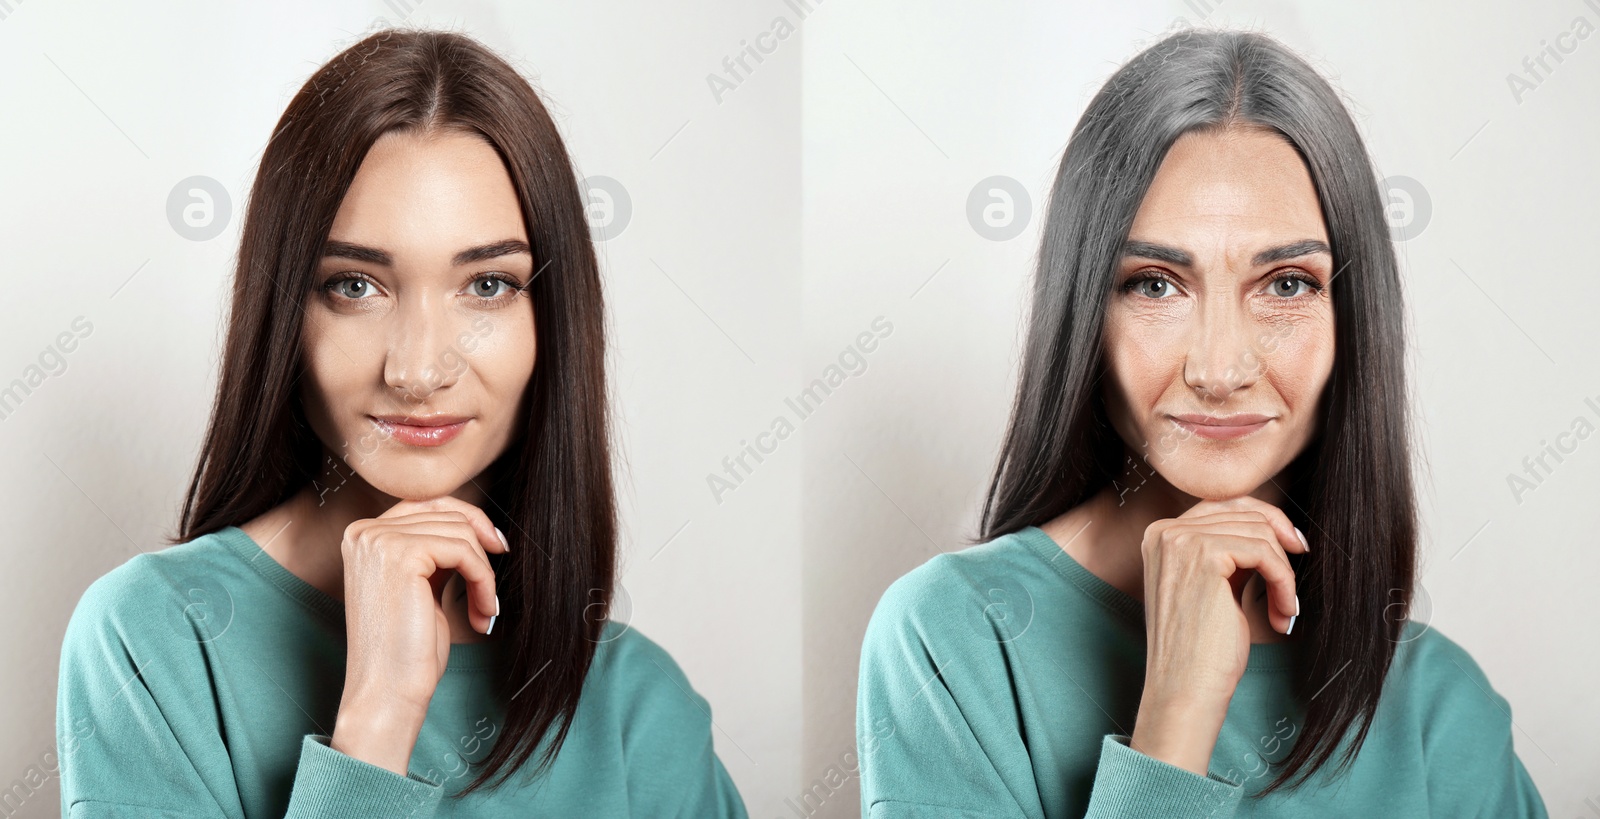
[[1042, 128, 1336, 776]]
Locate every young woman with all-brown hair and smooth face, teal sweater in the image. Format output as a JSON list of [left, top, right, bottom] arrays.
[[58, 30, 744, 817]]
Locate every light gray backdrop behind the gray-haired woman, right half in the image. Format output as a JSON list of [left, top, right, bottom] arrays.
[[797, 0, 1600, 817]]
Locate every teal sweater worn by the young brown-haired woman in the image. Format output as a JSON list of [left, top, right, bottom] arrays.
[[56, 526, 746, 819]]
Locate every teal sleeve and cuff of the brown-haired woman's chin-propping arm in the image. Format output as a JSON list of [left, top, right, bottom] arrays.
[[56, 555, 442, 819]]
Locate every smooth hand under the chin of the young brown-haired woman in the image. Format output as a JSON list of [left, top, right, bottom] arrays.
[[321, 496, 507, 776]]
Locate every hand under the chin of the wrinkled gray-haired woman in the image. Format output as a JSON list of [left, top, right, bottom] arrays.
[[1133, 496, 1309, 776]]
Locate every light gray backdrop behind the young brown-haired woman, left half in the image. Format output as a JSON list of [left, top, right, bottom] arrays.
[[0, 0, 802, 816]]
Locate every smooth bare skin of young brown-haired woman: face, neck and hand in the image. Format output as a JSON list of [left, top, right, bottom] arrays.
[[240, 131, 536, 776]]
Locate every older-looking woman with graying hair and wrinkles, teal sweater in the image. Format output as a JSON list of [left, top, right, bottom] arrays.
[[858, 30, 1546, 819]]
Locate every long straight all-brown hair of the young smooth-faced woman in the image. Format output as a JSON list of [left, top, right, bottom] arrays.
[[170, 29, 616, 793]]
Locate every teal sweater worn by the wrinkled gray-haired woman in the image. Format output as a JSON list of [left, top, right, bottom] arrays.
[[856, 526, 1547, 819]]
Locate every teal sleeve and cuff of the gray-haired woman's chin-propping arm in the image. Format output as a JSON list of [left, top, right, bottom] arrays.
[[856, 558, 1243, 819]]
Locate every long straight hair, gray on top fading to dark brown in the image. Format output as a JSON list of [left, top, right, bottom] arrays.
[[981, 30, 1416, 795]]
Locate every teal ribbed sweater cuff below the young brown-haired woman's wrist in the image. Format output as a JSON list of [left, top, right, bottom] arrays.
[[288, 734, 445, 819]]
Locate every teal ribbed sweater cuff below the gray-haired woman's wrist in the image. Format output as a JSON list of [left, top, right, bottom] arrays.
[[1088, 734, 1245, 819]]
